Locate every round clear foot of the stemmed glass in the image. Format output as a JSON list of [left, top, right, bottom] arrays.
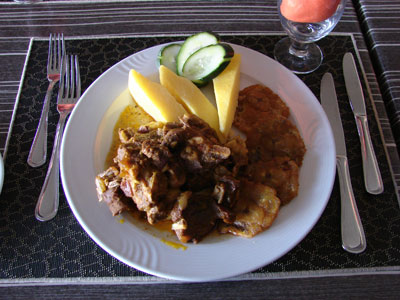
[[274, 37, 323, 74]]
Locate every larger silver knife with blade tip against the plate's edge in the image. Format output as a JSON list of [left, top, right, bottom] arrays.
[[321, 73, 367, 253]]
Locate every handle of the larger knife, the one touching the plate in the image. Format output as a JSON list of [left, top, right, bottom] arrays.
[[336, 155, 367, 253]]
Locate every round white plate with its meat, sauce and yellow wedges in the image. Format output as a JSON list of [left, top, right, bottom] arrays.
[[61, 32, 336, 281]]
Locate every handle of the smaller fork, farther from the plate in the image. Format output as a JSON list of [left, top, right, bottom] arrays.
[[28, 80, 57, 168]]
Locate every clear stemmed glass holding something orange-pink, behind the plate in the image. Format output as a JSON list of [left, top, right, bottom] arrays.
[[274, 0, 346, 74]]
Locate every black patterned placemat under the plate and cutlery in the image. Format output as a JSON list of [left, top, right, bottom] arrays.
[[0, 35, 400, 279]]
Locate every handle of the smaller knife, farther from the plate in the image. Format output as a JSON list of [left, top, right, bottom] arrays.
[[355, 116, 383, 195]]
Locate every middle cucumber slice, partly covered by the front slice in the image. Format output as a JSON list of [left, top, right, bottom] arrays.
[[176, 31, 219, 75]]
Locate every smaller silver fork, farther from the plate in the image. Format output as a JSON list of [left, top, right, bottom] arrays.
[[28, 34, 65, 167]]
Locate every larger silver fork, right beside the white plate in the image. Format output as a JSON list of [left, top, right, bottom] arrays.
[[35, 55, 81, 221]]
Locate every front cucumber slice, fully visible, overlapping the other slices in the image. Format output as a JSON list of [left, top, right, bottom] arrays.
[[182, 43, 234, 84]]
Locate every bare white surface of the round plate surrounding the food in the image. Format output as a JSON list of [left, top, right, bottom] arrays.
[[61, 45, 335, 281]]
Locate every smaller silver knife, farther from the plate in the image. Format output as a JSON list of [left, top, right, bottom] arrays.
[[343, 52, 383, 195]]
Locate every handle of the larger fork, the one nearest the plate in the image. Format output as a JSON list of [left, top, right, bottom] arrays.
[[35, 113, 68, 221]]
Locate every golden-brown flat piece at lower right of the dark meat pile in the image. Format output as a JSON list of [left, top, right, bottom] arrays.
[[219, 180, 280, 238]]
